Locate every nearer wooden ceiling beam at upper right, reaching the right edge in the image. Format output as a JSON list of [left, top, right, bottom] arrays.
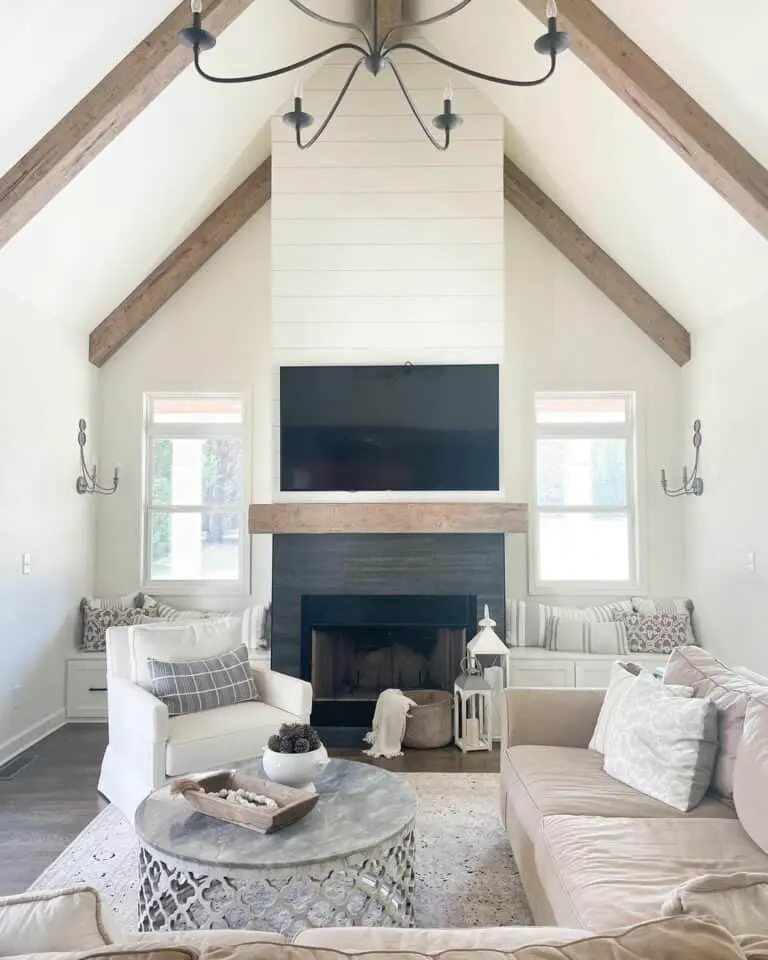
[[520, 0, 768, 244]]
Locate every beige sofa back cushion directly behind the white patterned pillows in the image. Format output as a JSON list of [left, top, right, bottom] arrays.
[[664, 646, 768, 802]]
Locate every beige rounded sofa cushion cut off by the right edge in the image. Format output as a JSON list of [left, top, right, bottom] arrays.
[[733, 696, 768, 853]]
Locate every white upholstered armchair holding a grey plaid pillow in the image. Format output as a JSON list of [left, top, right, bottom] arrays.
[[99, 618, 312, 820]]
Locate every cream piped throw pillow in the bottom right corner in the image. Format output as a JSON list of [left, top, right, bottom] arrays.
[[661, 873, 768, 936]]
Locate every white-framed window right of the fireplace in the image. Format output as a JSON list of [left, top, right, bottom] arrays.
[[531, 393, 638, 593]]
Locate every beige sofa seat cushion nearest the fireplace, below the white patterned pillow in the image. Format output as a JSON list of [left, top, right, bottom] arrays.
[[501, 745, 736, 837]]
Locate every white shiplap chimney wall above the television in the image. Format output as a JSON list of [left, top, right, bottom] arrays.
[[272, 55, 504, 366]]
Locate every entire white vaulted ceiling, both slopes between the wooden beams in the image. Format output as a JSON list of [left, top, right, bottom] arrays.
[[0, 0, 768, 332]]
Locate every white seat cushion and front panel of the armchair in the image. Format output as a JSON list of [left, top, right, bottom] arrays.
[[165, 701, 298, 777]]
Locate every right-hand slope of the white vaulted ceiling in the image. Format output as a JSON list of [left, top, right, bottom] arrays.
[[418, 0, 768, 331]]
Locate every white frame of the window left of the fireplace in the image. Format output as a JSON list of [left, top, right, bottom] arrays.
[[141, 391, 251, 596]]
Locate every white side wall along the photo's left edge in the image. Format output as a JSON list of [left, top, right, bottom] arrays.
[[0, 297, 97, 763]]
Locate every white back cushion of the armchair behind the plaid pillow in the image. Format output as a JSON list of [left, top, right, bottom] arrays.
[[127, 617, 242, 690]]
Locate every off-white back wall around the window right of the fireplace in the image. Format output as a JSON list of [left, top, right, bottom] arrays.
[[504, 206, 684, 599]]
